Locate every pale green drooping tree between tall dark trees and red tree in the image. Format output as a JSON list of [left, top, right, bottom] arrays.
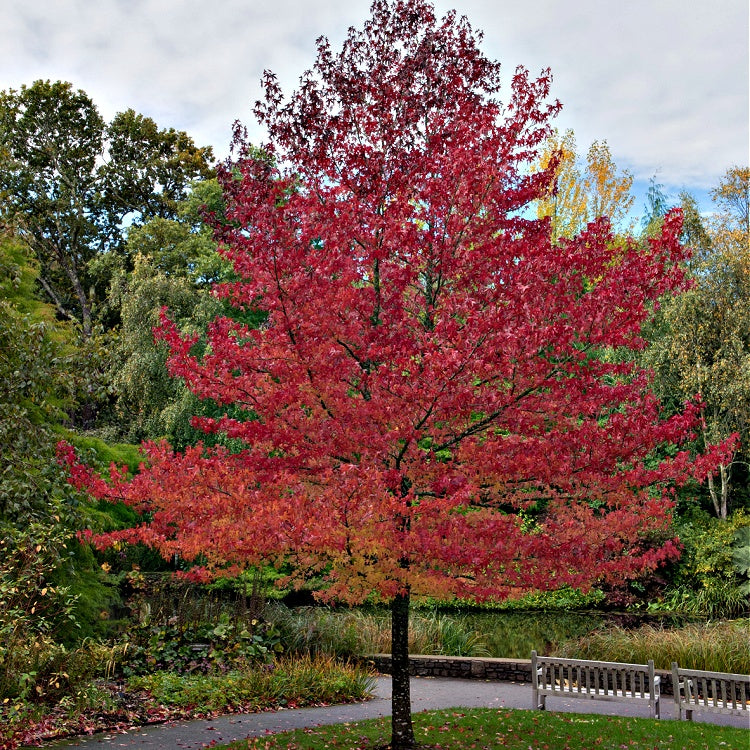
[[110, 180, 235, 445]]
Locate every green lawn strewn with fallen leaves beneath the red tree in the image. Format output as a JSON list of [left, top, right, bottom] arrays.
[[217, 709, 750, 750]]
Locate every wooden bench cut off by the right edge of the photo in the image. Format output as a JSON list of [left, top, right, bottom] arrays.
[[672, 662, 750, 721]]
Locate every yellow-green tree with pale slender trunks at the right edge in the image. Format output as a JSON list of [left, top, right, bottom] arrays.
[[646, 167, 750, 519]]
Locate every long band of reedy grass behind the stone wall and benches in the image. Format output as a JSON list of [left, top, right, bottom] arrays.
[[264, 604, 750, 673]]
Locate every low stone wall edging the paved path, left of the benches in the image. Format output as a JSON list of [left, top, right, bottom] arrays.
[[364, 654, 672, 695]]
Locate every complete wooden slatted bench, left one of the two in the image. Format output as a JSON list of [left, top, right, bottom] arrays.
[[531, 651, 660, 719]]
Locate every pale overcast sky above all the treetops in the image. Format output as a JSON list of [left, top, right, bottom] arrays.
[[0, 0, 749, 216]]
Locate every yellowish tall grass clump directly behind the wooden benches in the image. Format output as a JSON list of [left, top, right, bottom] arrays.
[[563, 618, 750, 674]]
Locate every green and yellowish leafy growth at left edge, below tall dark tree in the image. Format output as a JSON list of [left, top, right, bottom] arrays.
[[0, 225, 134, 652]]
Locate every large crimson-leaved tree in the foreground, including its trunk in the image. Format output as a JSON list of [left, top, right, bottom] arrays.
[[61, 0, 732, 750]]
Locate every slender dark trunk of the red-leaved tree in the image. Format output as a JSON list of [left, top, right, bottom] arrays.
[[391, 592, 416, 750]]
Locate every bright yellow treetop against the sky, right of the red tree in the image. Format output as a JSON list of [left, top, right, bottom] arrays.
[[536, 130, 634, 238]]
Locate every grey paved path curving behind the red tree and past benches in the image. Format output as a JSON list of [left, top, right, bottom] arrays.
[[46, 676, 750, 750]]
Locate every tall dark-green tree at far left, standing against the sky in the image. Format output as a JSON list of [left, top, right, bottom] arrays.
[[0, 81, 104, 335]]
